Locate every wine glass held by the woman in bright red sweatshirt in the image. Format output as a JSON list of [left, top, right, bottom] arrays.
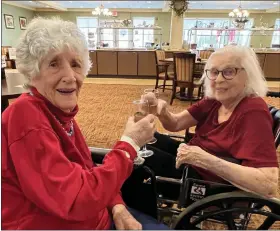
[[133, 99, 154, 157]]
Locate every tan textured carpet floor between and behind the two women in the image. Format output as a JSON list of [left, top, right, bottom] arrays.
[[76, 83, 280, 230]]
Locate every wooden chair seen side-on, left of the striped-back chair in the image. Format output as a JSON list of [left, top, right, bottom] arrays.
[[155, 50, 174, 92]]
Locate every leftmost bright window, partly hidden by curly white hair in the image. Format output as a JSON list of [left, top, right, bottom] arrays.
[[77, 17, 98, 49]]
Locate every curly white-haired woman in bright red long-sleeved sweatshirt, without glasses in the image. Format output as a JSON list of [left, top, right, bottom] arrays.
[[1, 17, 171, 230]]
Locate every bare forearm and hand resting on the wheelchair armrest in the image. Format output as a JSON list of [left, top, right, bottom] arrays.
[[176, 145, 278, 197]]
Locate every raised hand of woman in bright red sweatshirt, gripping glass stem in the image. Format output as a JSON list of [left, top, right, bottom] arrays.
[[123, 114, 156, 147]]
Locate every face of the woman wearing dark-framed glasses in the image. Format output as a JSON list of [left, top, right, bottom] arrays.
[[207, 54, 247, 103]]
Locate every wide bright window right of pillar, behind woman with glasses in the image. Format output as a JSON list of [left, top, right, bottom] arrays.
[[183, 18, 253, 49]]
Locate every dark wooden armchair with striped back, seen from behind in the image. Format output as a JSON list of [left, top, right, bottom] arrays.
[[170, 53, 202, 105]]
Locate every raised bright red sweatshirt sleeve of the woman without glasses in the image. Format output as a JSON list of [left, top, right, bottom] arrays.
[[10, 130, 136, 221]]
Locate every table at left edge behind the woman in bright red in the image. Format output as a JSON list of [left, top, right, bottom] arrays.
[[1, 72, 29, 113]]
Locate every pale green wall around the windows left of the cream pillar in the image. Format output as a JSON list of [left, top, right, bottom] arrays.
[[36, 12, 171, 42]]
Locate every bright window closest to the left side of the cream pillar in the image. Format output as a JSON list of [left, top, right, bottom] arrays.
[[133, 17, 155, 48]]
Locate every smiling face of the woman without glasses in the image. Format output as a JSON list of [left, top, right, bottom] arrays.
[[31, 50, 84, 112]]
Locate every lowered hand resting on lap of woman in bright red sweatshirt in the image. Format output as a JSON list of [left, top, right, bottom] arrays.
[[112, 205, 142, 230]]
